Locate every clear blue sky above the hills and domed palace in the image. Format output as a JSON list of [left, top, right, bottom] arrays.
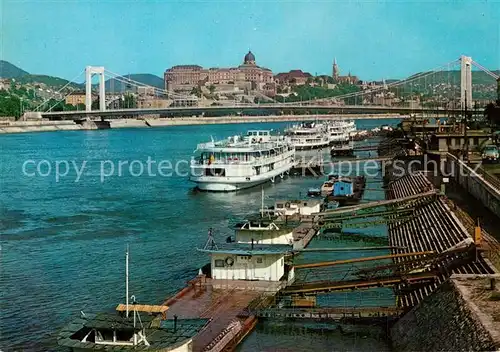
[[0, 0, 500, 81]]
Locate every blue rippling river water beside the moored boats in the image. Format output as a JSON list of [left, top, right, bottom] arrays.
[[0, 120, 398, 352]]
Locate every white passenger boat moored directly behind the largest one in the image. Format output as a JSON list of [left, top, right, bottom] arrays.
[[285, 122, 330, 150]]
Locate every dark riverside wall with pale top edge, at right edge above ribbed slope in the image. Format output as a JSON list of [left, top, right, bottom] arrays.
[[446, 153, 500, 217]]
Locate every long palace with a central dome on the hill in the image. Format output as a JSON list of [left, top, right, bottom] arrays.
[[164, 51, 274, 91]]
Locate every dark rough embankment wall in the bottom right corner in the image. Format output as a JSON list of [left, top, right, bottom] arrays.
[[391, 275, 500, 352]]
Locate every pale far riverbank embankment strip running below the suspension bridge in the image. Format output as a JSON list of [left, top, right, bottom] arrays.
[[0, 114, 406, 134]]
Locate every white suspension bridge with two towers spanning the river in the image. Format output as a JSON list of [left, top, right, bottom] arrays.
[[25, 55, 500, 119]]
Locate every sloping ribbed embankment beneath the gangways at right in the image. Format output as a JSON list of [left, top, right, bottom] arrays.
[[387, 172, 493, 309]]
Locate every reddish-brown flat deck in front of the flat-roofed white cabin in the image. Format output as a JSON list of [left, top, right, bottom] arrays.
[[164, 277, 280, 351]]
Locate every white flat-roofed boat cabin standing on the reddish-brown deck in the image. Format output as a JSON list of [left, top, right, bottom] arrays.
[[198, 243, 291, 282]]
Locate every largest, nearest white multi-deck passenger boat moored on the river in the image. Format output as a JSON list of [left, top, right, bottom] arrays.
[[190, 130, 295, 192]]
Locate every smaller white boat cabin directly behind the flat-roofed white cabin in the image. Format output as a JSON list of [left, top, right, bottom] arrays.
[[235, 220, 293, 245]]
